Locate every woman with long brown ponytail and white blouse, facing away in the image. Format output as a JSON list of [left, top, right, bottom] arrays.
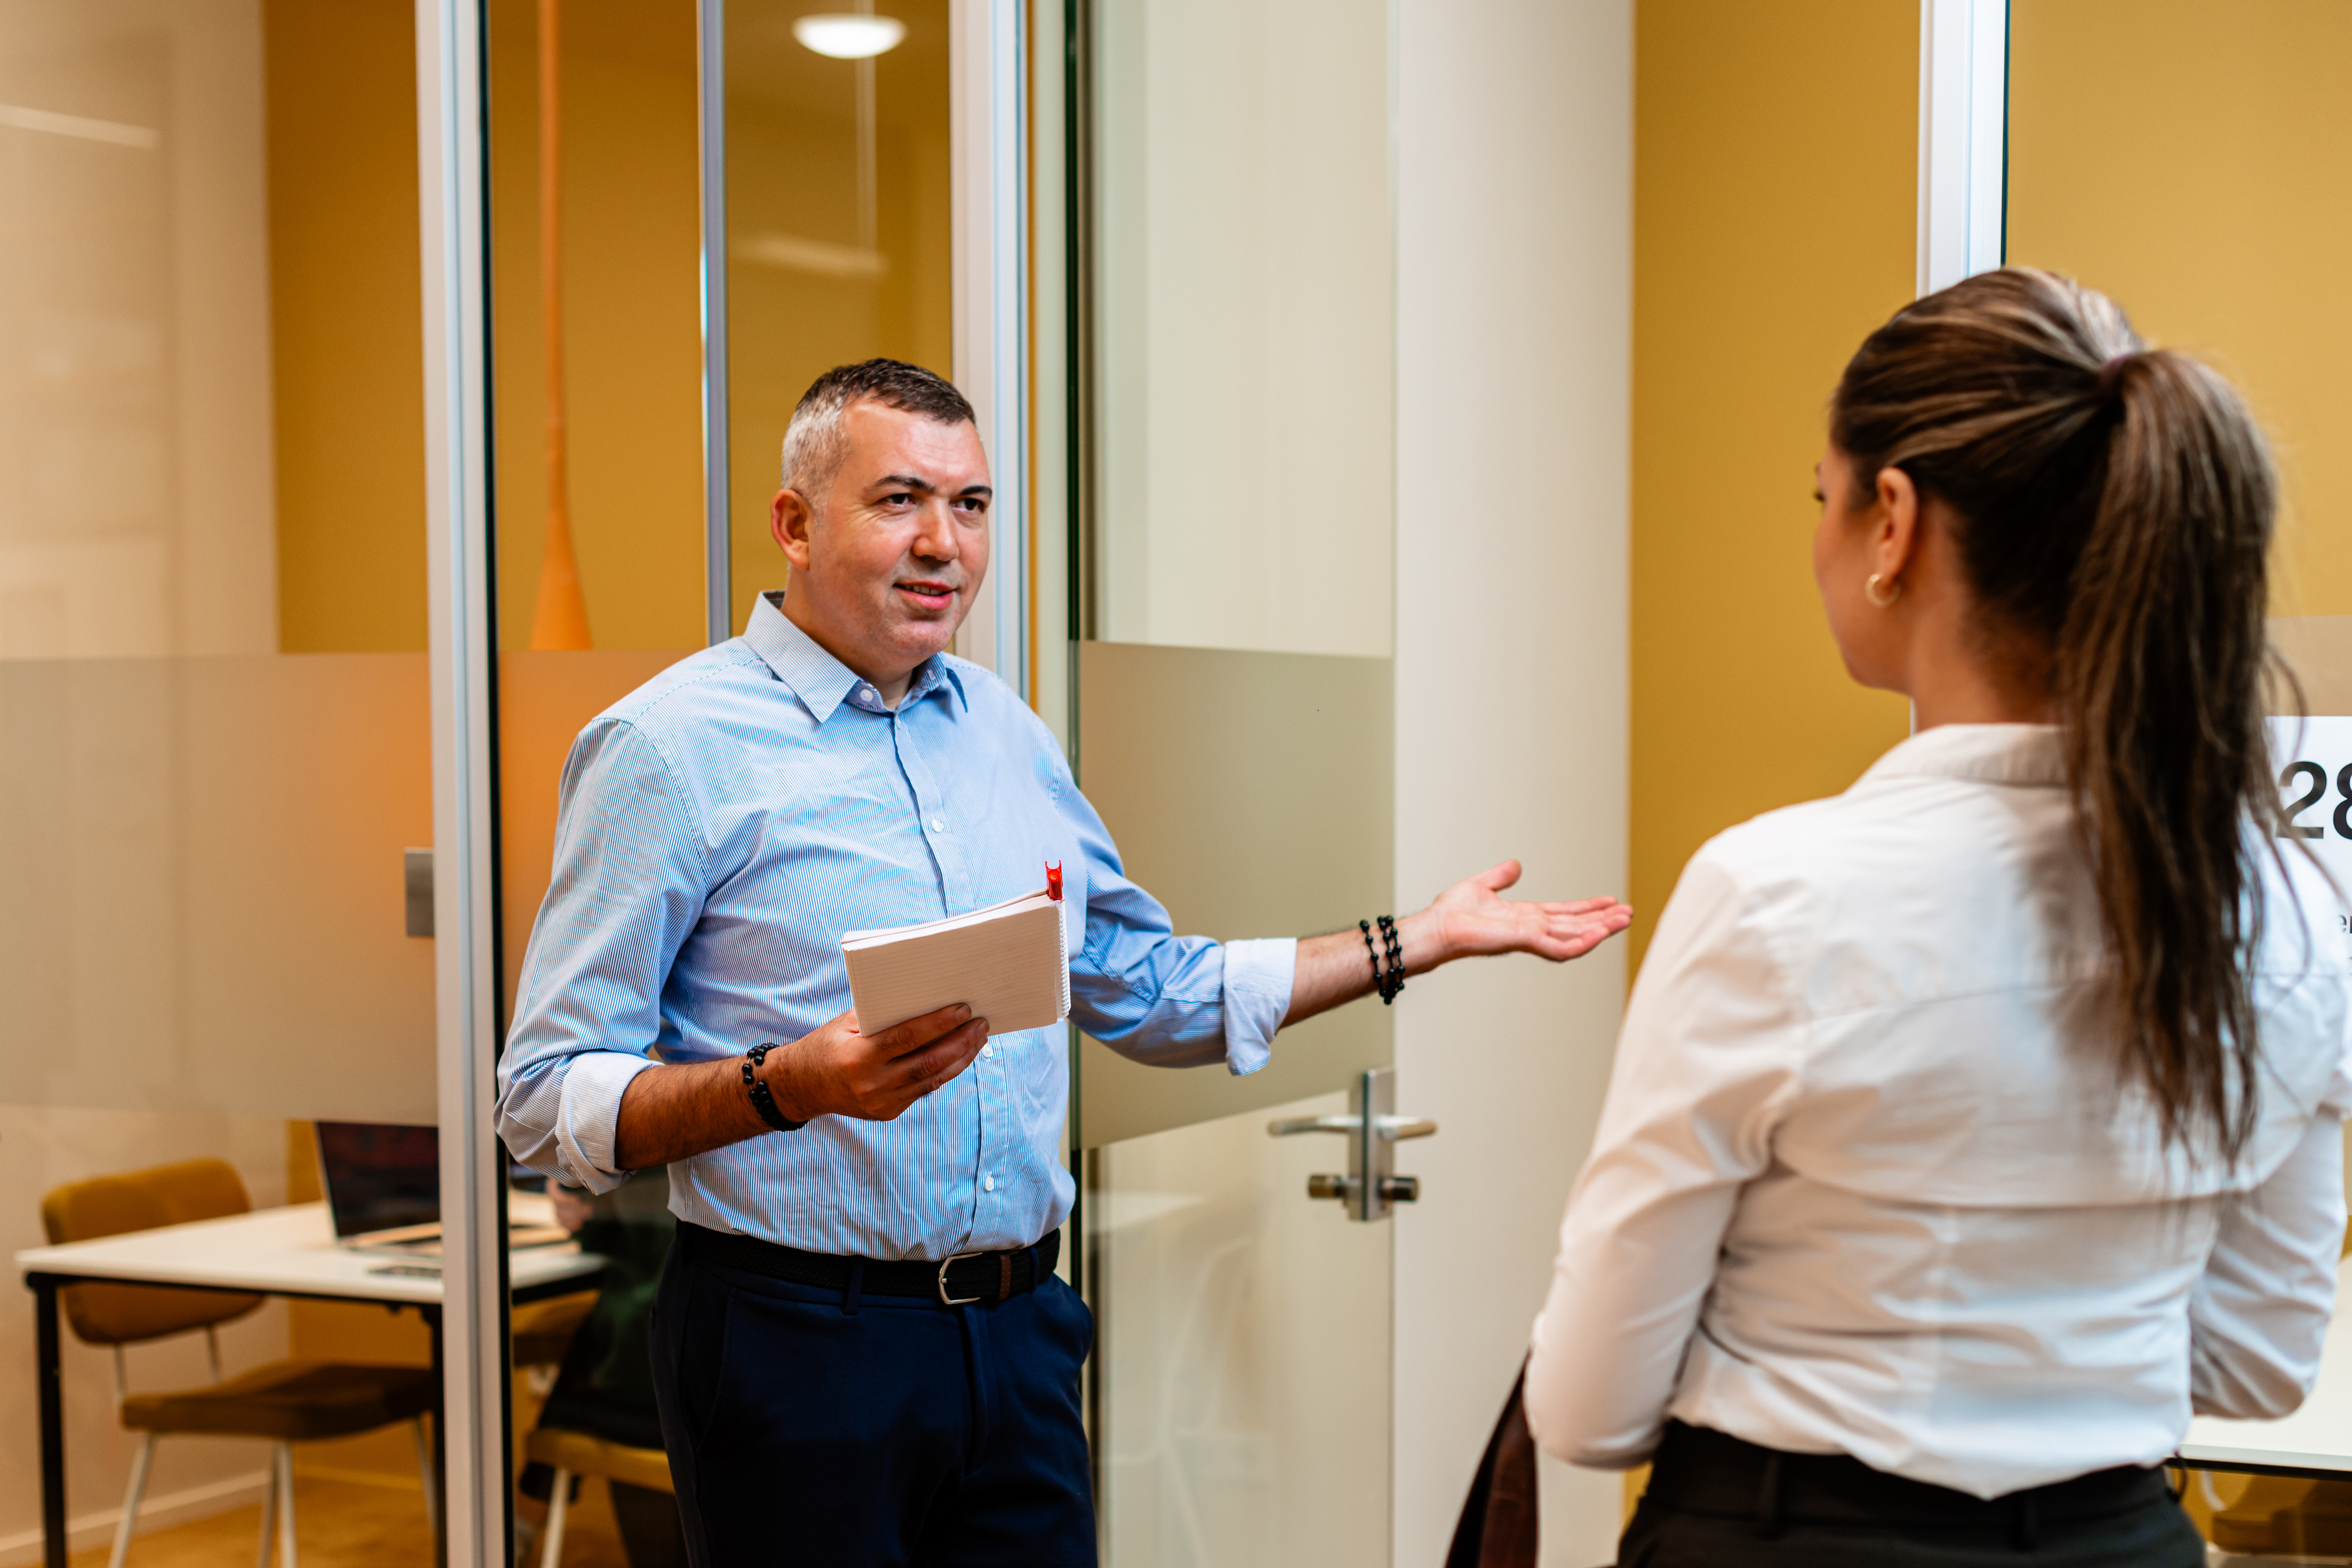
[[1526, 268, 2352, 1568]]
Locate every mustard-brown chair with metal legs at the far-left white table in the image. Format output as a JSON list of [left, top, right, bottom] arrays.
[[40, 1159, 440, 1568]]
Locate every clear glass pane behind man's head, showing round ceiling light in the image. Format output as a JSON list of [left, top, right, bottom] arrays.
[[727, 0, 955, 630]]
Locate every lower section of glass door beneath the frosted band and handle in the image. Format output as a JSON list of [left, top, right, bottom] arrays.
[[1089, 1093, 1395, 1568]]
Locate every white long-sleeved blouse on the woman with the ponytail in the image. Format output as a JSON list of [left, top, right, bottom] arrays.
[[1526, 724, 2352, 1497]]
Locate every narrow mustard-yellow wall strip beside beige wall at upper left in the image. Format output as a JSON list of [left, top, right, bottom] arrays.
[[261, 0, 426, 653]]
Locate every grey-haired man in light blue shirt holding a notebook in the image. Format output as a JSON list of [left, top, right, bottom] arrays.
[[499, 360, 1630, 1568]]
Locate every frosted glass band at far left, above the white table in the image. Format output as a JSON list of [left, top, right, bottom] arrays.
[[0, 653, 435, 1122]]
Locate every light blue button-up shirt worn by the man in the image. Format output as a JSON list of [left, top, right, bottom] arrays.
[[499, 595, 1296, 1258]]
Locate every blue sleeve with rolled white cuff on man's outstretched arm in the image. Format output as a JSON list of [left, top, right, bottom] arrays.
[[1054, 755, 1298, 1077]]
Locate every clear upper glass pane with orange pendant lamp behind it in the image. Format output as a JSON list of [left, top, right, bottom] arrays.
[[489, 0, 703, 653]]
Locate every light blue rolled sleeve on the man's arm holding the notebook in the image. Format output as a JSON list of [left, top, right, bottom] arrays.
[[499, 719, 708, 1192]]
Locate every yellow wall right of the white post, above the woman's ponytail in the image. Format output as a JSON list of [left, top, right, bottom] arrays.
[[2009, 0, 2352, 616]]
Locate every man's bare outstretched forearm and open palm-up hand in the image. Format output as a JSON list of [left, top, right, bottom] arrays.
[[1282, 860, 1632, 1025]]
